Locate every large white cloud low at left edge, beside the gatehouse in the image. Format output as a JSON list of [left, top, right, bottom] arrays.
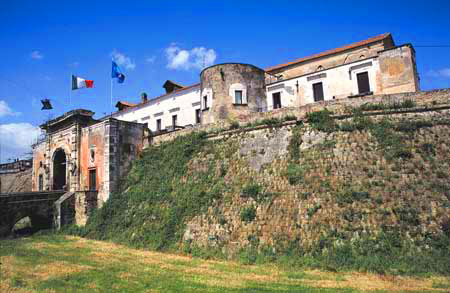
[[0, 123, 41, 161]]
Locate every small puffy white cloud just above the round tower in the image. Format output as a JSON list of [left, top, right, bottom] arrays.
[[165, 43, 217, 70]]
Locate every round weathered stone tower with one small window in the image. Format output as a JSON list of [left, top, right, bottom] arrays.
[[200, 63, 266, 124]]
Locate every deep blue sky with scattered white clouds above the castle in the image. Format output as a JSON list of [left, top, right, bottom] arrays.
[[0, 0, 450, 162]]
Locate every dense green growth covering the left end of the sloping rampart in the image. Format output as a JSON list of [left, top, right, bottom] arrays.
[[79, 133, 230, 249]]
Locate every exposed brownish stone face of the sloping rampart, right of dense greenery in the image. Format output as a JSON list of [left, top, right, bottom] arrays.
[[183, 110, 450, 254]]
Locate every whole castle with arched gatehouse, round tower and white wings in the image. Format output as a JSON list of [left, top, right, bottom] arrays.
[[32, 33, 419, 214]]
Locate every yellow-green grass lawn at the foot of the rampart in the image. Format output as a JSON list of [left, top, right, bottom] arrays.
[[0, 235, 450, 292]]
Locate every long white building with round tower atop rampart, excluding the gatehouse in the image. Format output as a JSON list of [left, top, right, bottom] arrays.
[[112, 33, 419, 128]]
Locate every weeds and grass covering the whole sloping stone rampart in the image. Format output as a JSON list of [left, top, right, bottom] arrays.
[[66, 105, 450, 275]]
